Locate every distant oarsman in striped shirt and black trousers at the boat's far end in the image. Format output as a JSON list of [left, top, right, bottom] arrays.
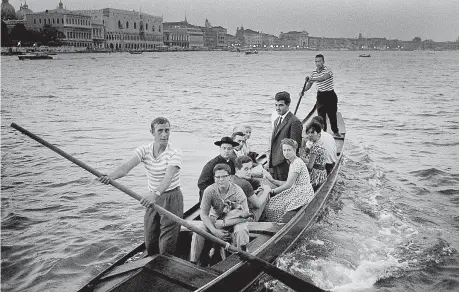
[[299, 54, 341, 137]]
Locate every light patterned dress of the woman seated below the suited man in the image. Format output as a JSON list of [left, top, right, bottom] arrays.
[[266, 157, 314, 222]]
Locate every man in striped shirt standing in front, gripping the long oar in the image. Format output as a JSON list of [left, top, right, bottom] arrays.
[[99, 117, 183, 255]]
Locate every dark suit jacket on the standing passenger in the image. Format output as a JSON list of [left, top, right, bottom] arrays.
[[269, 112, 303, 167]]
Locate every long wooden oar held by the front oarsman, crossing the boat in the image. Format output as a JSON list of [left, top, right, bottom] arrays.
[[11, 123, 323, 291]]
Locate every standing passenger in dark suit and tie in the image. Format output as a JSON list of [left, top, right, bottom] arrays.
[[269, 91, 303, 181]]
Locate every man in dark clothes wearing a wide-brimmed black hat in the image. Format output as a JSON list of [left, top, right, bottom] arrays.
[[198, 137, 239, 202]]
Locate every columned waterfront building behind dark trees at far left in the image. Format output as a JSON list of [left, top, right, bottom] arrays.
[[25, 1, 93, 48]]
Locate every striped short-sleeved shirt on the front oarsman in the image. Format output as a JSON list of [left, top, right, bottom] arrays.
[[134, 143, 182, 192]]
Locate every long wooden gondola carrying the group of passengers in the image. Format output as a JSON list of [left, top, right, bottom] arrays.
[[79, 113, 346, 292]]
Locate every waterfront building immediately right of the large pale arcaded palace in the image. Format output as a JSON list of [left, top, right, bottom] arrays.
[[163, 17, 204, 49]]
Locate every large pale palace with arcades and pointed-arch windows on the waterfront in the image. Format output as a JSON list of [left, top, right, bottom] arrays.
[[79, 8, 163, 51]]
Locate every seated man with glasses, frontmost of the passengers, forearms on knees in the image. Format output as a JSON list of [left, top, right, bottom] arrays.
[[190, 163, 250, 263]]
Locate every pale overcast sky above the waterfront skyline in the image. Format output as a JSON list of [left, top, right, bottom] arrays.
[[9, 0, 459, 41]]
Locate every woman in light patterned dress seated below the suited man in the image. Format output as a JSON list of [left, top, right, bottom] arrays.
[[266, 139, 314, 222]]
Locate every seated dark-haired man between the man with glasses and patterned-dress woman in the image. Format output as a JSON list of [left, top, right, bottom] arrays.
[[233, 155, 271, 221]]
